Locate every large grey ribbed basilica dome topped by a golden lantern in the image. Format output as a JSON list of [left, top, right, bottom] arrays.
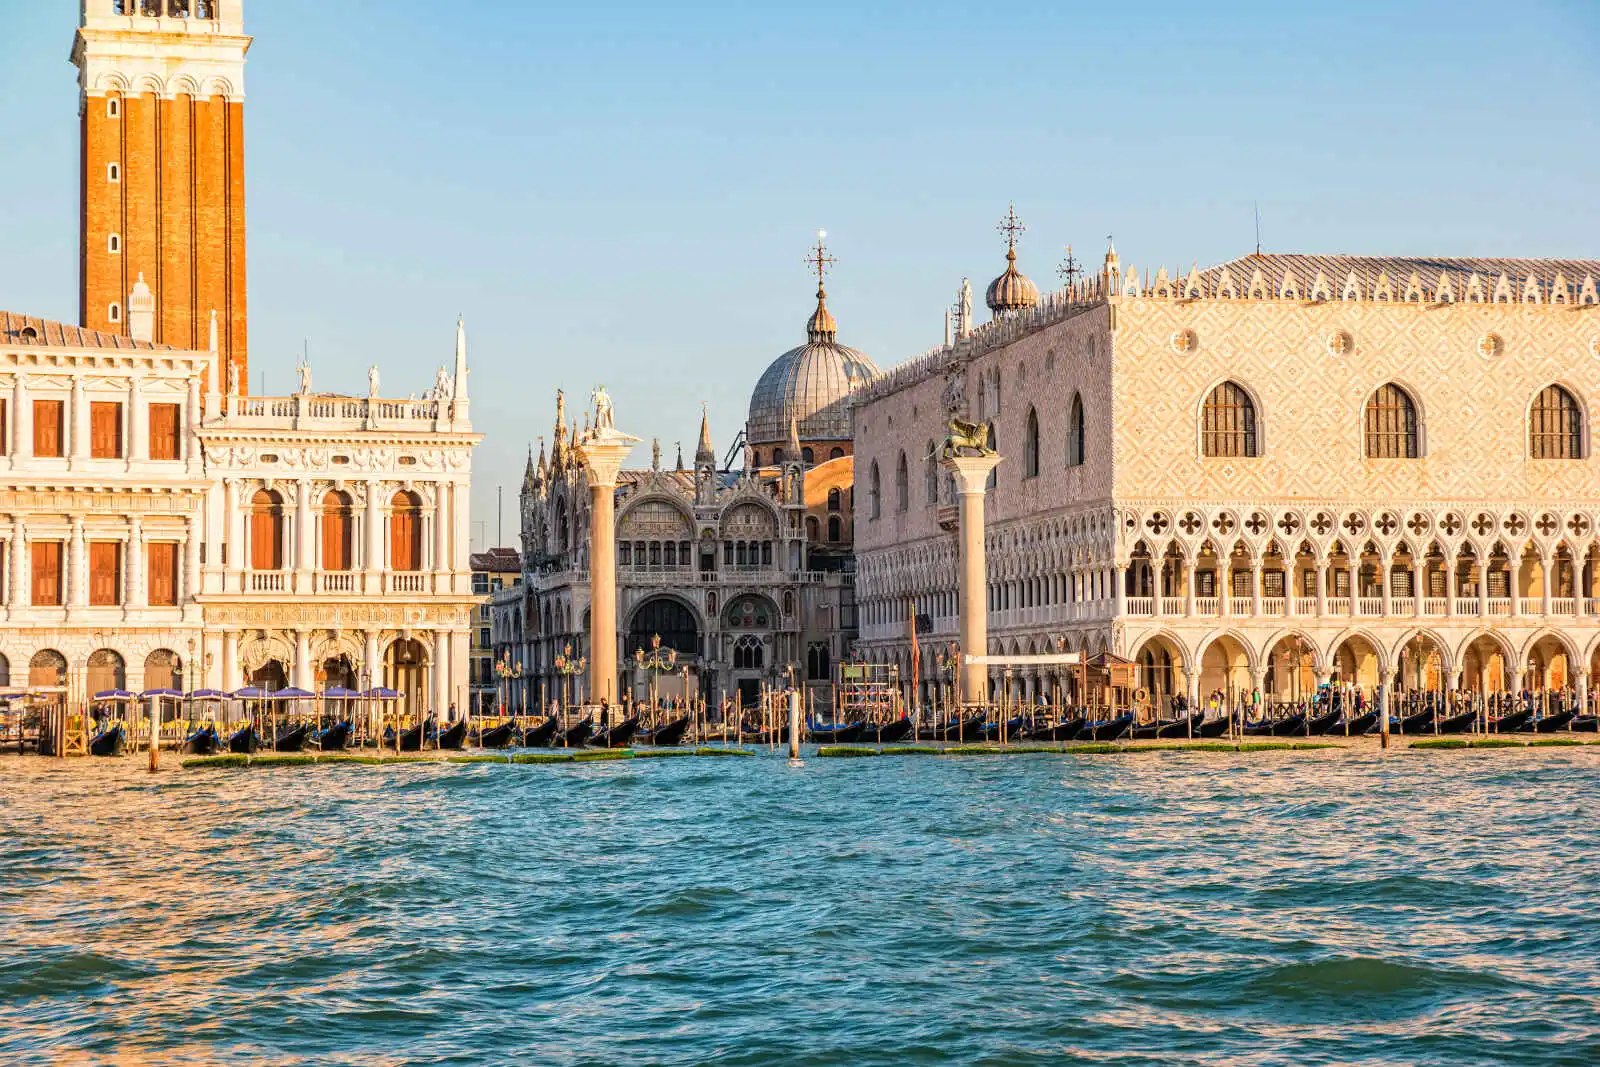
[[744, 288, 882, 445]]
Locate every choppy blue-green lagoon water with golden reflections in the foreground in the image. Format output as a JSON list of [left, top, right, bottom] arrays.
[[0, 752, 1600, 1067]]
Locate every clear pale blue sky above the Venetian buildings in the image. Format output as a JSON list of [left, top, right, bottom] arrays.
[[0, 0, 1600, 542]]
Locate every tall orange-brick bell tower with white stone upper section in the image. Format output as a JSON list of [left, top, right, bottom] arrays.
[[72, 0, 250, 389]]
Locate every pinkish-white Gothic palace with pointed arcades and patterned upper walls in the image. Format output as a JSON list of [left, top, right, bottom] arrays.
[[856, 222, 1600, 713]]
